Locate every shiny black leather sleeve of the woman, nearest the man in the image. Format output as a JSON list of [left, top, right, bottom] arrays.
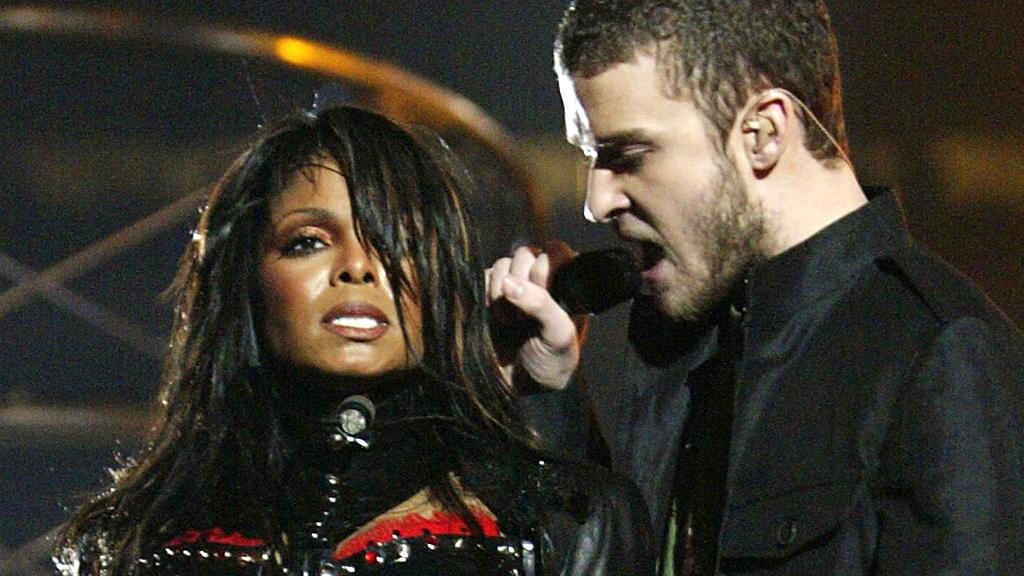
[[560, 473, 656, 576]]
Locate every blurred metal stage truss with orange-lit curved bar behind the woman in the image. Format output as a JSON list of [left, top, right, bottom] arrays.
[[0, 6, 549, 561]]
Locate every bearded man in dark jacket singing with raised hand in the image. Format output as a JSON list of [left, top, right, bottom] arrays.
[[488, 0, 1024, 575]]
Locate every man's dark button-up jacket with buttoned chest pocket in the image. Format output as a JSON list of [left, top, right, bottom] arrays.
[[581, 191, 1024, 575]]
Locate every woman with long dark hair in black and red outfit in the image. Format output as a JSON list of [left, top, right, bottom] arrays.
[[56, 108, 652, 576]]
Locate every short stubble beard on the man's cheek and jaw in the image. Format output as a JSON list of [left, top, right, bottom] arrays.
[[657, 156, 766, 322]]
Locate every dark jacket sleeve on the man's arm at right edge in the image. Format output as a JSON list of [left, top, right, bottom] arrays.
[[872, 319, 1024, 575]]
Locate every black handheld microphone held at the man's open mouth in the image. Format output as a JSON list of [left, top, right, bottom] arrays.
[[549, 242, 641, 314]]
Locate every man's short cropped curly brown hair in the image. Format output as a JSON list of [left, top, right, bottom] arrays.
[[555, 0, 847, 159]]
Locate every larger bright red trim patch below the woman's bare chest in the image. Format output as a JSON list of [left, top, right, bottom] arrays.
[[332, 507, 501, 560]]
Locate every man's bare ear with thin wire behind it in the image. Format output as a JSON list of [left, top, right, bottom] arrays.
[[739, 90, 794, 173]]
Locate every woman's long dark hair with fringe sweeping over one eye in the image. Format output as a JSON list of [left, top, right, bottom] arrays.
[[57, 107, 532, 575]]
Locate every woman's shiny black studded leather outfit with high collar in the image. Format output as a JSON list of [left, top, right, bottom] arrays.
[[70, 379, 656, 576]]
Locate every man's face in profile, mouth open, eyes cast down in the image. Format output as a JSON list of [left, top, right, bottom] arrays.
[[563, 52, 764, 320]]
